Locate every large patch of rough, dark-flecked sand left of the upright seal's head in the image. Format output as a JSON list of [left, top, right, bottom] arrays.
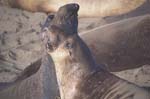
[[0, 7, 46, 81]]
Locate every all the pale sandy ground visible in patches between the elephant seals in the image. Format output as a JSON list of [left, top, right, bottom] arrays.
[[0, 4, 150, 87]]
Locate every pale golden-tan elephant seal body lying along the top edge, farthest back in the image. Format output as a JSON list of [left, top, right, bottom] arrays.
[[0, 0, 146, 17]]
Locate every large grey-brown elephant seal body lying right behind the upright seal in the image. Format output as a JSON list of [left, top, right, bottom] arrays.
[[79, 14, 150, 72]]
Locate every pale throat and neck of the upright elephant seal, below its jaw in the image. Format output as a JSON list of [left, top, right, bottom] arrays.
[[49, 35, 96, 99]]
